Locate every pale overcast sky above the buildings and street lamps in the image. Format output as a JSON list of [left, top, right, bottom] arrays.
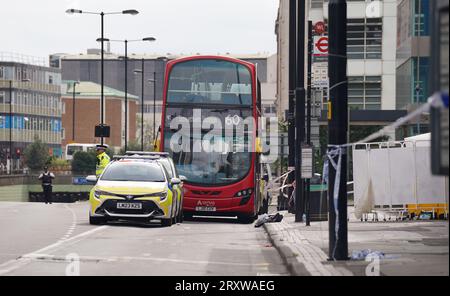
[[0, 0, 279, 57]]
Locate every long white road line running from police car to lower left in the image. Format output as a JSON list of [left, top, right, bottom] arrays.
[[0, 225, 108, 275]]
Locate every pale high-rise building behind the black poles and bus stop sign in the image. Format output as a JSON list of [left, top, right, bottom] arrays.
[[276, 0, 405, 143]]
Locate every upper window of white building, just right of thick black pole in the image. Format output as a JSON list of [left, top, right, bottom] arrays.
[[347, 18, 383, 59]]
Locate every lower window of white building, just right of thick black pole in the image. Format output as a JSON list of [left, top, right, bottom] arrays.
[[348, 76, 381, 110]]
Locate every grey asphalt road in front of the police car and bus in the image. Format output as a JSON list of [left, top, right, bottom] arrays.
[[0, 202, 290, 276]]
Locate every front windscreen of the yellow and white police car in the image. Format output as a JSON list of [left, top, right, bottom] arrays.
[[101, 162, 165, 182]]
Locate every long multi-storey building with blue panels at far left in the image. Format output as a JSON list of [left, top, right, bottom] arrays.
[[0, 53, 62, 169]]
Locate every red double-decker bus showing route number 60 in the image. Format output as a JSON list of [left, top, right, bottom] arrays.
[[160, 56, 263, 223]]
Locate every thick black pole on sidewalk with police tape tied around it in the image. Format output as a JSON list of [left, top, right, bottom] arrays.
[[328, 0, 348, 260]]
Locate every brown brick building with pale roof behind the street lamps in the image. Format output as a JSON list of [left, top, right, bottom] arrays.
[[61, 81, 138, 150]]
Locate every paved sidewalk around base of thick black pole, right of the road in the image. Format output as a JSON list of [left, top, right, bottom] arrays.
[[264, 208, 449, 276]]
